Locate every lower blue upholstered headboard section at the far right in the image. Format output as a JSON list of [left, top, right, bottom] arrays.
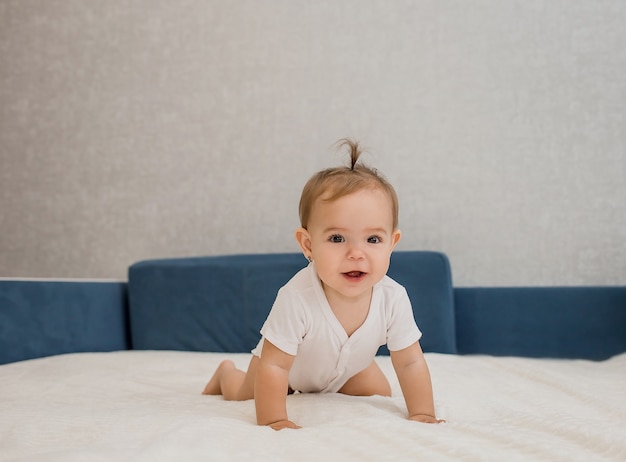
[[454, 286, 626, 360]]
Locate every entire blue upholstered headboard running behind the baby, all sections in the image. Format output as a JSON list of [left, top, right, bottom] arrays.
[[0, 251, 626, 364]]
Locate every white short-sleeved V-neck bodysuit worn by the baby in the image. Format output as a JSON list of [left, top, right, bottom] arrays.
[[252, 263, 422, 393]]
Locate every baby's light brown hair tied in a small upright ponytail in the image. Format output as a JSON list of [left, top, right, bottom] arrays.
[[299, 139, 398, 230]]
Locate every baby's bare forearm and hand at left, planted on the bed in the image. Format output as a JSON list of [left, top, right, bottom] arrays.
[[254, 339, 300, 430]]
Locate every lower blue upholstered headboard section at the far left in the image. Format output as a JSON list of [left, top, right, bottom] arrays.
[[0, 280, 130, 364]]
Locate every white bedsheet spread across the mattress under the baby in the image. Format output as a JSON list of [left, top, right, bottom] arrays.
[[0, 351, 626, 462]]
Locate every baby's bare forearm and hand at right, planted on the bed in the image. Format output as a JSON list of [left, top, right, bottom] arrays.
[[391, 342, 443, 423]]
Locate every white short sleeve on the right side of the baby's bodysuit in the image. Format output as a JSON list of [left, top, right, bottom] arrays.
[[387, 285, 422, 351]]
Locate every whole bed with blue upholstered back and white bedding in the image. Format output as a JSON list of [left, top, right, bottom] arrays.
[[0, 252, 626, 462]]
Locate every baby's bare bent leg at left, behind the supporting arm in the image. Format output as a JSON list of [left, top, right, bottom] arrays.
[[202, 356, 259, 401]]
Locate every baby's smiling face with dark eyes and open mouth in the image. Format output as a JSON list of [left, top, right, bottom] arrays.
[[308, 189, 400, 305]]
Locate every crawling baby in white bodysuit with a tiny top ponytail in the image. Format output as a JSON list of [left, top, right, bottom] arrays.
[[203, 140, 442, 430]]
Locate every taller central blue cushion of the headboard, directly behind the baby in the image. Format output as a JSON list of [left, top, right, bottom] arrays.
[[128, 251, 456, 353]]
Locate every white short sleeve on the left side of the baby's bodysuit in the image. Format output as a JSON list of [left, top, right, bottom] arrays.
[[261, 287, 307, 356]]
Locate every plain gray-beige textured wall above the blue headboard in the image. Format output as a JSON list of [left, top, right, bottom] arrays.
[[0, 0, 626, 285]]
